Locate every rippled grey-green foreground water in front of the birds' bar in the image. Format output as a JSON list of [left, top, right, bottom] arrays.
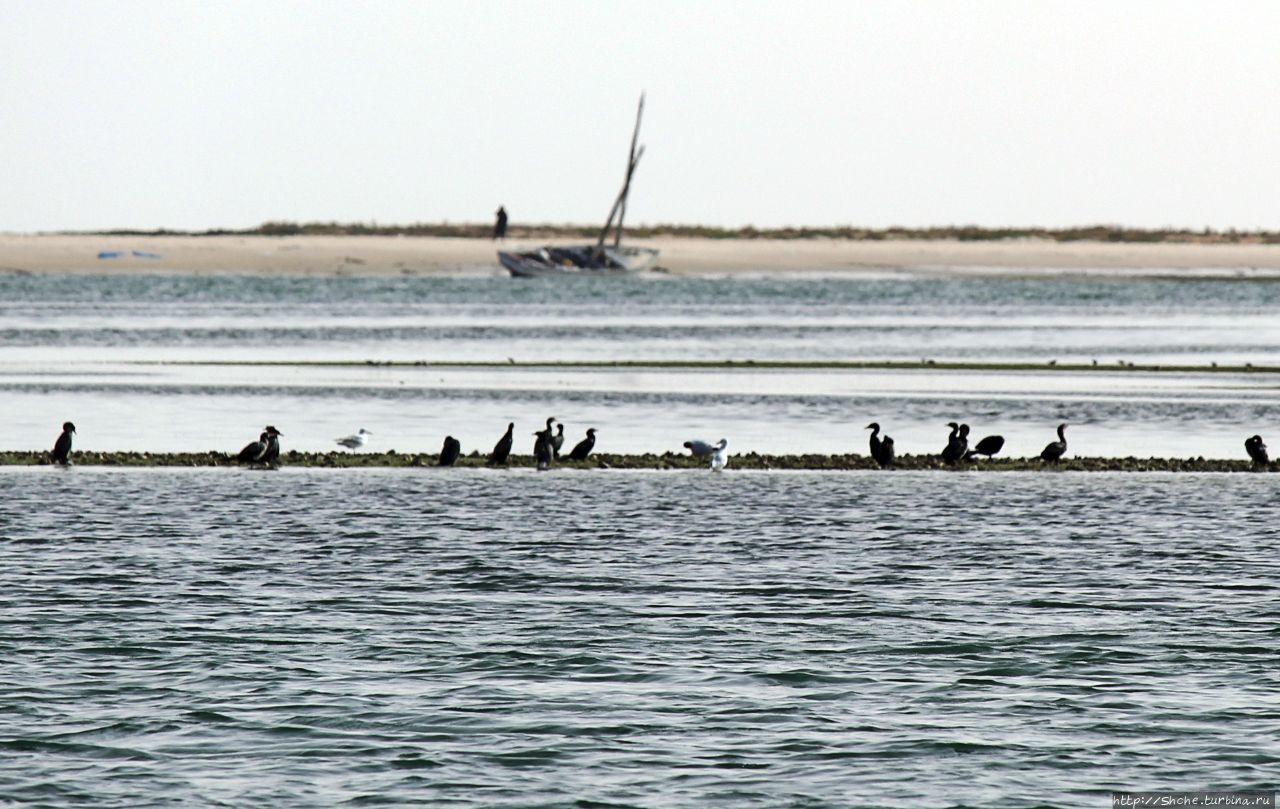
[[0, 467, 1280, 808]]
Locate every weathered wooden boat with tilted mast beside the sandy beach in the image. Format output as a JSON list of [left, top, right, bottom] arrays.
[[498, 93, 658, 278]]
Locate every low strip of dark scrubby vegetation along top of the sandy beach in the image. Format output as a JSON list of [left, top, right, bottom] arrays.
[[70, 220, 1280, 244]]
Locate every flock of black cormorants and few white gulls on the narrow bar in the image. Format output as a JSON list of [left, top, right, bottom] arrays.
[[40, 416, 1271, 471]]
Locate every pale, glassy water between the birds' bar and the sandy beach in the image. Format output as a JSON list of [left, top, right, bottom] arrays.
[[0, 274, 1280, 457]]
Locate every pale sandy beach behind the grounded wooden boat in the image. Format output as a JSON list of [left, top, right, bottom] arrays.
[[0, 234, 1280, 278]]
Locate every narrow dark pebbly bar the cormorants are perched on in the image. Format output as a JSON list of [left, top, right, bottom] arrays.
[[0, 451, 1280, 474]]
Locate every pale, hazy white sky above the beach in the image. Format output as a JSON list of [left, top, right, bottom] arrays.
[[0, 0, 1280, 232]]
